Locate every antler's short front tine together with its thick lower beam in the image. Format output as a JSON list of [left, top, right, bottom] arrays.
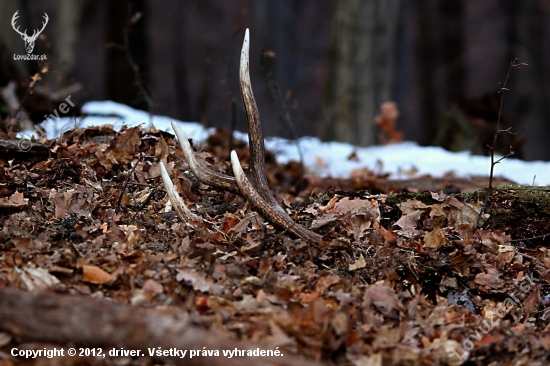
[[231, 150, 322, 243]]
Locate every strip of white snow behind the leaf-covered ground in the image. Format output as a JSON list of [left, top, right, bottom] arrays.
[[18, 101, 550, 185]]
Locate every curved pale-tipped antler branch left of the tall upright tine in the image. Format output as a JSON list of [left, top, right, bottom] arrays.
[[172, 122, 240, 193]]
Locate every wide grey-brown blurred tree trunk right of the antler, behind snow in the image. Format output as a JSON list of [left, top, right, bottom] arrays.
[[323, 0, 400, 146]]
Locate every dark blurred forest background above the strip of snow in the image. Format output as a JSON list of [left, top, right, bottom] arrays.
[[0, 0, 550, 160]]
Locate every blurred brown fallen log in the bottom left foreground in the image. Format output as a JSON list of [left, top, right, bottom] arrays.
[[0, 288, 328, 366]]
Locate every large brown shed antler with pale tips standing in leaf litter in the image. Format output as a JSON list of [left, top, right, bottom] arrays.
[[161, 29, 322, 243]]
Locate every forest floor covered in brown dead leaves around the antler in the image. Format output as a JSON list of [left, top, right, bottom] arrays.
[[0, 127, 550, 366]]
